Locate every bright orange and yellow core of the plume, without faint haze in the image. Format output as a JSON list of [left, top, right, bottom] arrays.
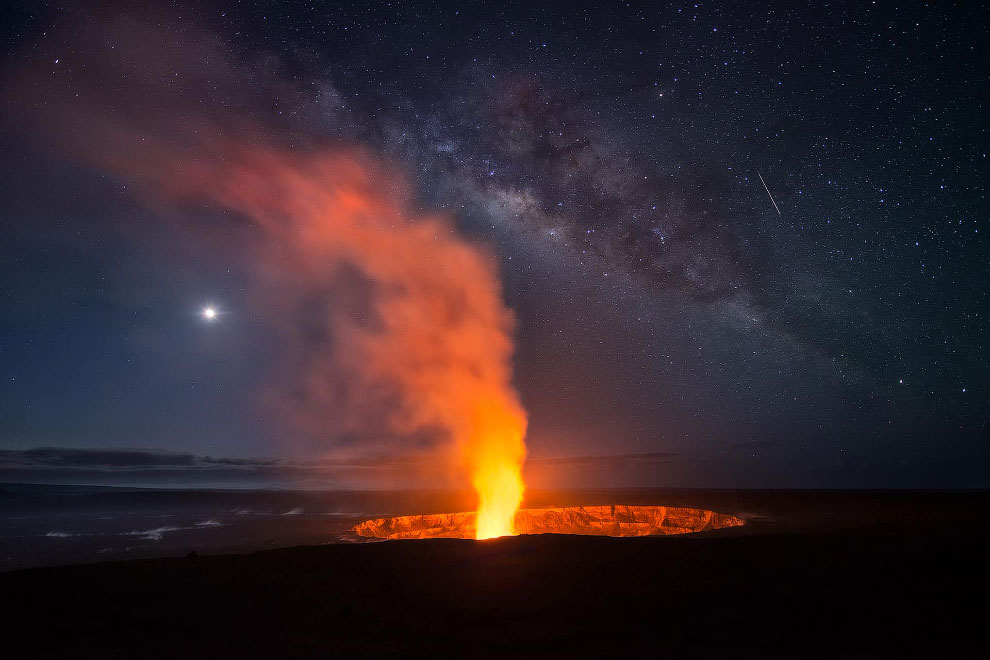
[[196, 149, 526, 538]]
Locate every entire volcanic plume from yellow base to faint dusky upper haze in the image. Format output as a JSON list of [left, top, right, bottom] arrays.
[[7, 9, 526, 538]]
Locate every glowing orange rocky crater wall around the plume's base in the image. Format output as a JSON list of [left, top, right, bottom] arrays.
[[353, 505, 745, 540]]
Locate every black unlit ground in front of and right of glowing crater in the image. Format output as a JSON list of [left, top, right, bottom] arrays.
[[0, 493, 990, 658]]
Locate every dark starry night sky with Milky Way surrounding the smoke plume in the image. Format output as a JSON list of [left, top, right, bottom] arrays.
[[0, 2, 990, 488]]
